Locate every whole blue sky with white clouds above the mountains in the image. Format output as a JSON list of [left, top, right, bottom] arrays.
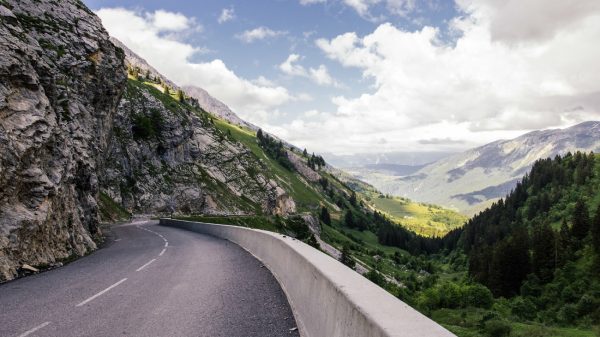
[[84, 0, 600, 154]]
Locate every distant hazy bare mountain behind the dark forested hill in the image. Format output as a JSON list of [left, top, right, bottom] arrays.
[[357, 122, 600, 214]]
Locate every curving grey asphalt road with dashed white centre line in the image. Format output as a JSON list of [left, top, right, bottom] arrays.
[[0, 221, 298, 337]]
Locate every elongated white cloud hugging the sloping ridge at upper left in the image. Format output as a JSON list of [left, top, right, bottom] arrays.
[[96, 8, 292, 122]]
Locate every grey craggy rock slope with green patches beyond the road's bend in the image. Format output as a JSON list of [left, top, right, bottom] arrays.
[[101, 79, 295, 214]]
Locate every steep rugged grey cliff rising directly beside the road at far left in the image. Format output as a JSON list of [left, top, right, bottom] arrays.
[[0, 0, 126, 281]]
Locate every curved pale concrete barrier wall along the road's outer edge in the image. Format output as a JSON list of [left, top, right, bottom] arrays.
[[160, 219, 454, 337]]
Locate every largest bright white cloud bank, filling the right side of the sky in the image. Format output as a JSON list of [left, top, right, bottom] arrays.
[[271, 0, 600, 153]]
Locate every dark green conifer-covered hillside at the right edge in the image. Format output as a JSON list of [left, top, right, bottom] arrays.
[[436, 152, 600, 334]]
